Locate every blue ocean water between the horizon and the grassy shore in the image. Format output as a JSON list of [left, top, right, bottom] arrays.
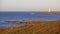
[[0, 12, 60, 28]]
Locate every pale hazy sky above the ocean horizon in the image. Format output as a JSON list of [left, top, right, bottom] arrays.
[[0, 0, 60, 11]]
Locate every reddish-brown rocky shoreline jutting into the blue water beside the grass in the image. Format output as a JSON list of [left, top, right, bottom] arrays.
[[4, 20, 59, 24]]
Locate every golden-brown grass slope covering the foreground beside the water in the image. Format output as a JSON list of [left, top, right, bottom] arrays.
[[0, 20, 60, 34]]
